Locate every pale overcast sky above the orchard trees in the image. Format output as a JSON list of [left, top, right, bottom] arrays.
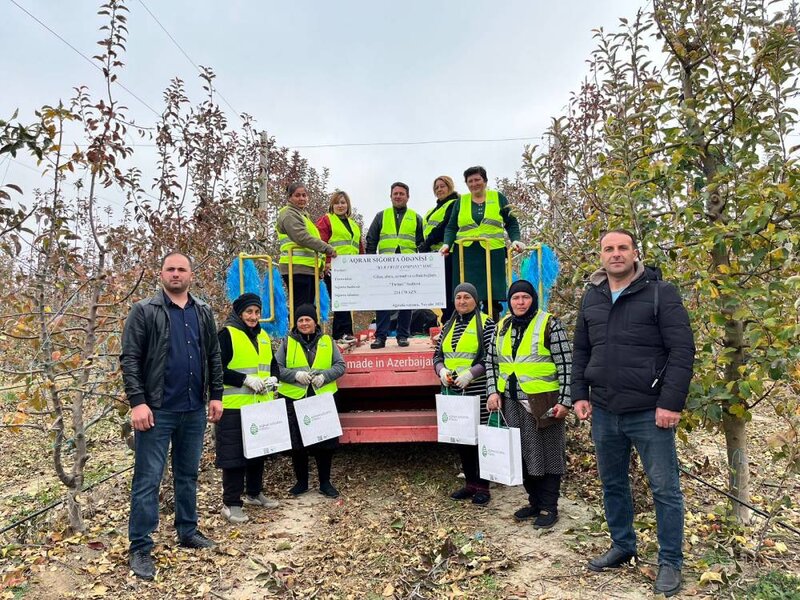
[[0, 0, 643, 219]]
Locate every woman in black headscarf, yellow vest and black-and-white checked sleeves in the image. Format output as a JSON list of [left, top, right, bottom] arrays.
[[486, 279, 572, 529]]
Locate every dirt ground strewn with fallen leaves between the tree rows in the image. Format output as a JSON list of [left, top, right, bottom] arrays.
[[0, 410, 800, 600]]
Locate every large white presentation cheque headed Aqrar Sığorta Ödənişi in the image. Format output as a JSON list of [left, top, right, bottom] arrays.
[[331, 252, 446, 310]]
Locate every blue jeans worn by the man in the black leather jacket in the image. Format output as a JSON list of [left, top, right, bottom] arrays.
[[128, 408, 206, 552]]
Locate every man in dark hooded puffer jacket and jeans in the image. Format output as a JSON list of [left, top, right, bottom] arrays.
[[571, 229, 695, 596]]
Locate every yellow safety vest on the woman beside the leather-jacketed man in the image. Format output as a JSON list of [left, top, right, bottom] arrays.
[[222, 325, 273, 409]]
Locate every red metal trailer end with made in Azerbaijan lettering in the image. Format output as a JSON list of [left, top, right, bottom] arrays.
[[336, 331, 440, 444]]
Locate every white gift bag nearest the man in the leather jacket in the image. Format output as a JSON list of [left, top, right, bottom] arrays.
[[240, 398, 292, 458]]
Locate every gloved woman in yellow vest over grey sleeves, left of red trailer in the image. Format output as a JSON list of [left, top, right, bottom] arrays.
[[275, 304, 345, 498]]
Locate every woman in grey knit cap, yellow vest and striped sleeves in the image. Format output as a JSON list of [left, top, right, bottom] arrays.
[[433, 283, 495, 505]]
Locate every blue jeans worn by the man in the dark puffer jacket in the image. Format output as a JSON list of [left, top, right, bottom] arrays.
[[592, 407, 683, 569]]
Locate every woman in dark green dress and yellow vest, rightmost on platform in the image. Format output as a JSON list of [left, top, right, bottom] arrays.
[[439, 167, 525, 320]]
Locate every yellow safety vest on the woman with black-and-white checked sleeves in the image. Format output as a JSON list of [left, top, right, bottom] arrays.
[[496, 310, 559, 396]]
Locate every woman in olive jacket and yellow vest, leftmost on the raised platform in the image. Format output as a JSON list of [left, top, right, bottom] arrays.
[[275, 183, 336, 309]]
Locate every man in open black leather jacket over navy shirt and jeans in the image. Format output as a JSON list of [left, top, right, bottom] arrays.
[[120, 252, 223, 579]]
